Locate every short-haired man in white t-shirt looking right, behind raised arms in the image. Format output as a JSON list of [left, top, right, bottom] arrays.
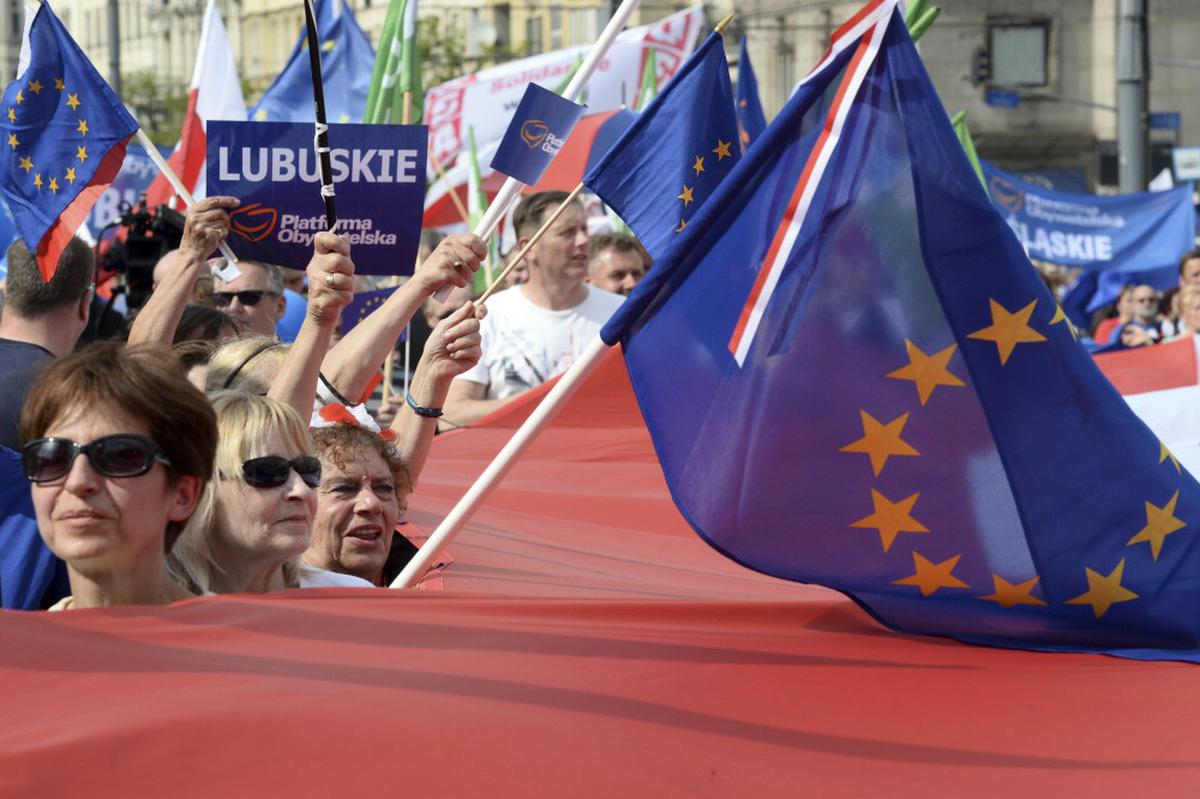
[[445, 192, 624, 425]]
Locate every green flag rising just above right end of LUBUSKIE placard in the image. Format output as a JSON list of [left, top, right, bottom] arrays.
[[362, 0, 425, 124]]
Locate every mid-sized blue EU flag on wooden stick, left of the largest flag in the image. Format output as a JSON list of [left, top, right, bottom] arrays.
[[583, 34, 742, 258]]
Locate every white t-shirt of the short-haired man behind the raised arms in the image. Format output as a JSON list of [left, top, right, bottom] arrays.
[[457, 286, 625, 400]]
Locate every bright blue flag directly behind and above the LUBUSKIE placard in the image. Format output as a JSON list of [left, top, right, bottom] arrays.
[[250, 0, 374, 122]]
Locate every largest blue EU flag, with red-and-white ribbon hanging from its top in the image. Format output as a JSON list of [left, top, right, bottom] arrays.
[[601, 0, 1200, 661]]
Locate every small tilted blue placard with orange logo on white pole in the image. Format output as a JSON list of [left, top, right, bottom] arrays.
[[492, 83, 588, 186]]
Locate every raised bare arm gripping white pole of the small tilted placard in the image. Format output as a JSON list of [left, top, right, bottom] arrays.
[[320, 233, 487, 402]]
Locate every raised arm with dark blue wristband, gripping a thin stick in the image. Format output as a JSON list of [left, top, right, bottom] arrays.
[[391, 302, 486, 487]]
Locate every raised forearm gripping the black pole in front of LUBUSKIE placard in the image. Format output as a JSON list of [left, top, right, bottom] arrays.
[[266, 232, 354, 420]]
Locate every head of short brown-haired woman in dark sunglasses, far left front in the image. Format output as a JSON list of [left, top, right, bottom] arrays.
[[22, 342, 217, 609]]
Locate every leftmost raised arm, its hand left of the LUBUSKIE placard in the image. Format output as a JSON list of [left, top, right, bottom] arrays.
[[130, 197, 241, 344]]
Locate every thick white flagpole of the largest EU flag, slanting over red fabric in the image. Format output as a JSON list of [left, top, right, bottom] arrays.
[[391, 336, 608, 588]]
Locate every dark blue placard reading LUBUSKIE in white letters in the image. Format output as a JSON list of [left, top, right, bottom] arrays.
[[208, 121, 428, 275]]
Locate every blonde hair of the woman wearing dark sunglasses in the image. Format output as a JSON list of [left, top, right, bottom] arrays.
[[167, 391, 313, 594]]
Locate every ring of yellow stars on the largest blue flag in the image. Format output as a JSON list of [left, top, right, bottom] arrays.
[[839, 299, 1188, 619]]
